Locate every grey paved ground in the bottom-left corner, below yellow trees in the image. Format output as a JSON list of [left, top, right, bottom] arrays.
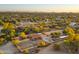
[[0, 42, 19, 54]]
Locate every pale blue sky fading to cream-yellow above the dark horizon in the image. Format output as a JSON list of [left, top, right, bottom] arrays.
[[0, 4, 79, 12]]
